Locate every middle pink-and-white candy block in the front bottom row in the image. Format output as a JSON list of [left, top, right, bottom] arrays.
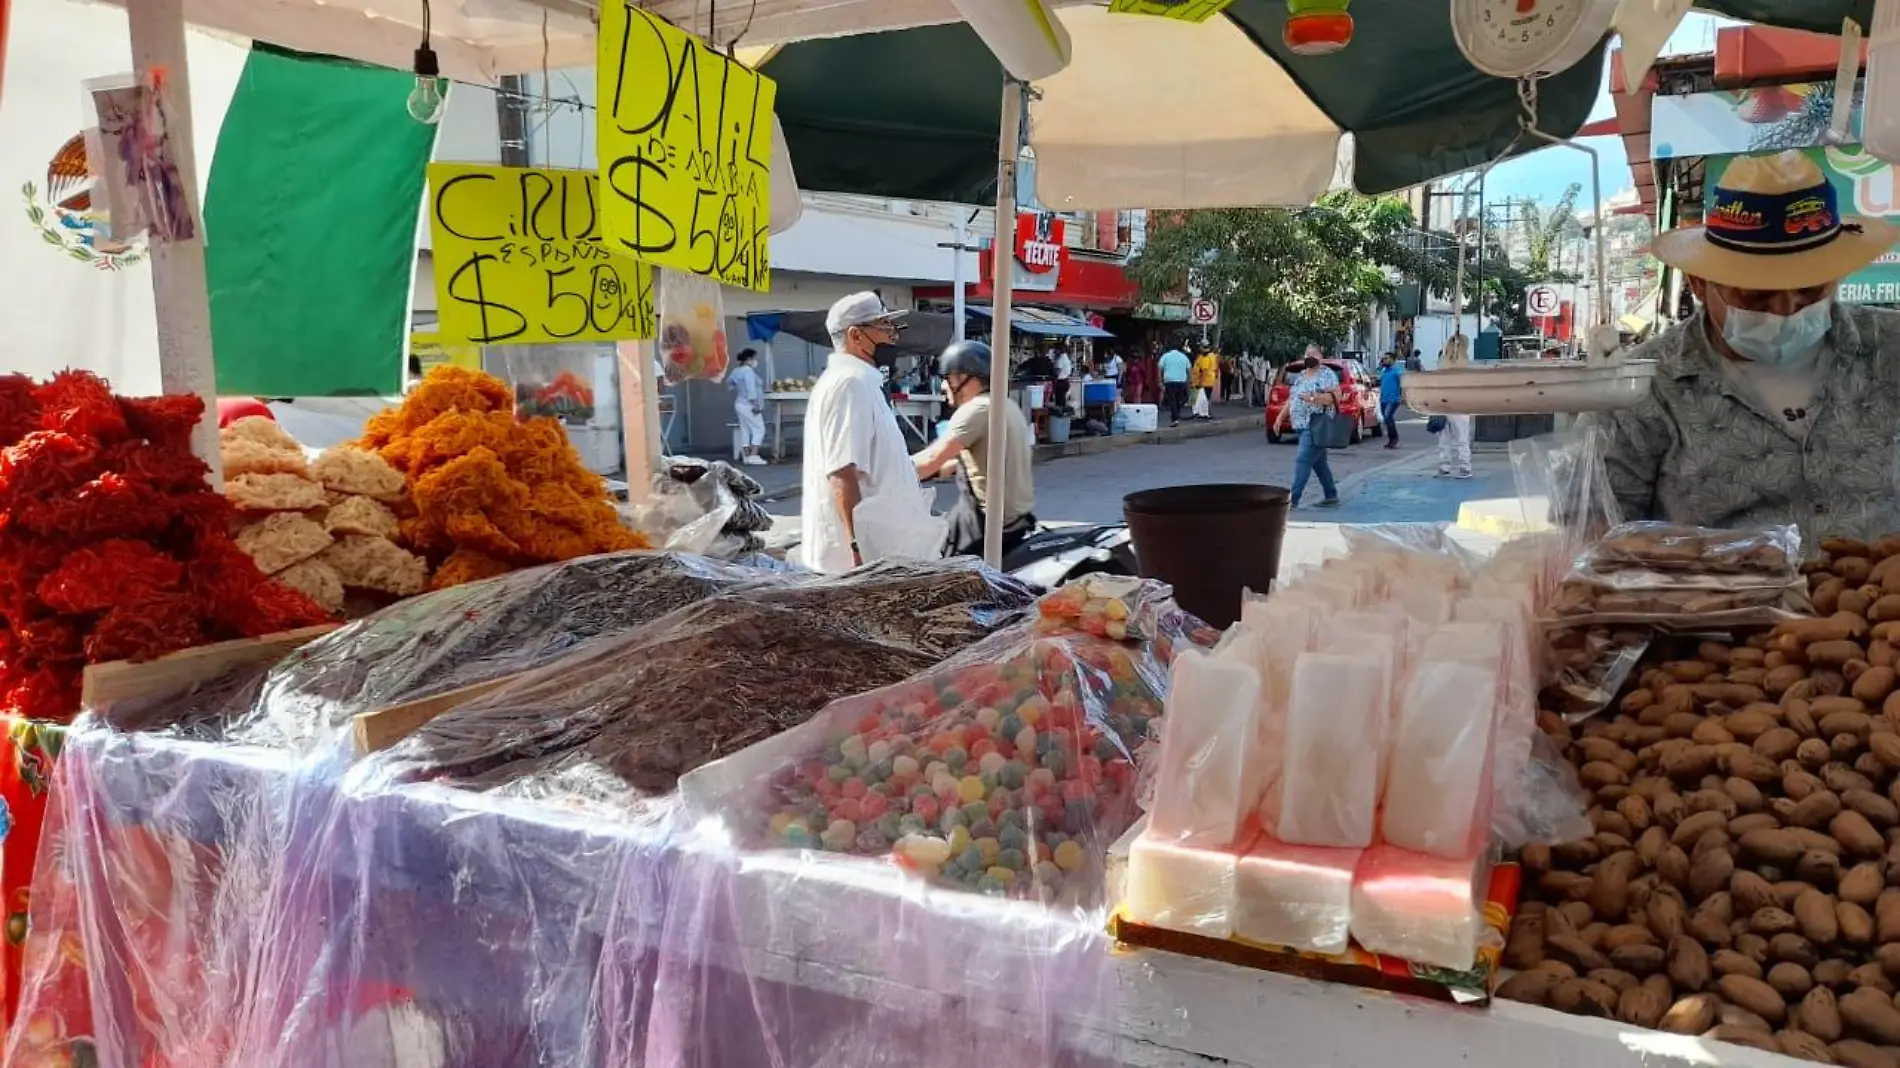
[[1233, 834, 1364, 954]]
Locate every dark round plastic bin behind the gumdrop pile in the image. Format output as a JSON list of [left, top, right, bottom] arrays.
[[1121, 483, 1292, 627]]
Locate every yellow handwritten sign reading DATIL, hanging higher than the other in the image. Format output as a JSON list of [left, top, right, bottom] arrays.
[[597, 0, 779, 291]]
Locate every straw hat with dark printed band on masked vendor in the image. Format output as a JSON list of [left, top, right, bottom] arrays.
[[1653, 150, 1900, 289]]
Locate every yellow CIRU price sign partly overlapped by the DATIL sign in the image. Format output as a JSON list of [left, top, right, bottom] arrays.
[[429, 163, 654, 344]]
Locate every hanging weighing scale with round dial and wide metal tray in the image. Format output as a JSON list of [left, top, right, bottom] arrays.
[[1402, 0, 1655, 416]]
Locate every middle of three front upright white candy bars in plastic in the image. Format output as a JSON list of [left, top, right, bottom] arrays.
[[1277, 652, 1387, 848]]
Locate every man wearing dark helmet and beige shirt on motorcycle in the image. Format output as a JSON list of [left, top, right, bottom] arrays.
[[910, 342, 1036, 557]]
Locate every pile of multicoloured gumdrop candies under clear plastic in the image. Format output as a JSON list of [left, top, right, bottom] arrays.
[[680, 582, 1212, 906]]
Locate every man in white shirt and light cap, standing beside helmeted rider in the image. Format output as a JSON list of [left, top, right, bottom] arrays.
[[798, 291, 923, 574]]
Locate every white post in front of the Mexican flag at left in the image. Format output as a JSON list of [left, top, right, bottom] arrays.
[[126, 0, 224, 478]]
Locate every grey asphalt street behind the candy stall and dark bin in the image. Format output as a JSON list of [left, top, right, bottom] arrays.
[[729, 418, 1537, 574]]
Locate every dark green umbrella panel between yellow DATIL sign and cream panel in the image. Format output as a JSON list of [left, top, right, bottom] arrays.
[[762, 23, 1003, 203]]
